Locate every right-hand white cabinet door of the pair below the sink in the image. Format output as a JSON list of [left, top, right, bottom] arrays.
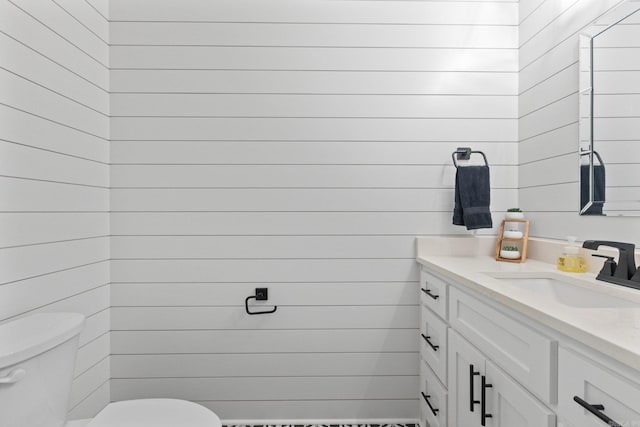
[[480, 360, 556, 427]]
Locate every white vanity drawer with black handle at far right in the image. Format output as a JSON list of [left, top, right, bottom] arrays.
[[558, 348, 640, 427]]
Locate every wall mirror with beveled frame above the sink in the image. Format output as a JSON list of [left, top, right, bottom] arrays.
[[579, 0, 640, 216]]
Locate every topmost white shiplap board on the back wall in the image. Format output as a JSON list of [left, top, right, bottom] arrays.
[[110, 0, 518, 25]]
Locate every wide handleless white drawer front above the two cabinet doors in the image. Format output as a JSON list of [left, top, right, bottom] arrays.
[[449, 287, 558, 403]]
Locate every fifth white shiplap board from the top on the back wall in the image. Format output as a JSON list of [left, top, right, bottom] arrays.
[[111, 94, 518, 119]]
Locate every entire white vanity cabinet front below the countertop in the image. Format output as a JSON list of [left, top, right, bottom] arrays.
[[418, 266, 640, 427]]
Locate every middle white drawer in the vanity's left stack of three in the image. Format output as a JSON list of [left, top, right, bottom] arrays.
[[420, 304, 447, 384]]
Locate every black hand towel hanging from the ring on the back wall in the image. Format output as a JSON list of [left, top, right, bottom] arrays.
[[453, 166, 493, 230]]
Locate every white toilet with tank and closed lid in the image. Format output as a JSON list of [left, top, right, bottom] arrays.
[[0, 313, 221, 427]]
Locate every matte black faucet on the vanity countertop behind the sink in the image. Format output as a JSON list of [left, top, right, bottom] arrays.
[[582, 240, 640, 287]]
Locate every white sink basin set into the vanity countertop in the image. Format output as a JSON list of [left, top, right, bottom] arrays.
[[487, 273, 640, 308]]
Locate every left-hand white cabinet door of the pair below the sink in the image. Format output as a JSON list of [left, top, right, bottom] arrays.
[[448, 329, 485, 427]]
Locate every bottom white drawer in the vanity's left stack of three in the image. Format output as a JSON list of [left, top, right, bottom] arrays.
[[420, 361, 447, 427]]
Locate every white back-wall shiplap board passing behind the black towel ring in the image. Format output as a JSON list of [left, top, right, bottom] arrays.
[[111, 142, 518, 166]]
